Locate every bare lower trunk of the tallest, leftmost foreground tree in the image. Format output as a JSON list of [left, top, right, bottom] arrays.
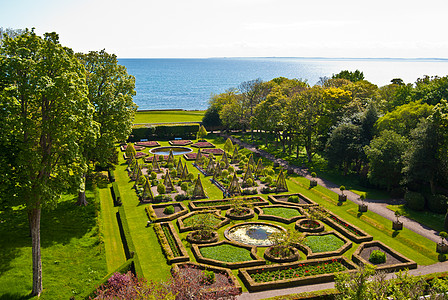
[[30, 208, 42, 296]]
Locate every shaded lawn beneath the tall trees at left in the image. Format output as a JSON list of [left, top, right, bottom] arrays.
[[0, 190, 107, 299]]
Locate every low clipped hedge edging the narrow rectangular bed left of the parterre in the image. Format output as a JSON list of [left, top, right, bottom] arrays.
[[154, 222, 190, 264]]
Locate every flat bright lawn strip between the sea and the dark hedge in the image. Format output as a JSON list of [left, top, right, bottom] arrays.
[[134, 110, 205, 124]]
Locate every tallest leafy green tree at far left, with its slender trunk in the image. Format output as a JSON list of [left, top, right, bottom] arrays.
[[0, 30, 94, 295]]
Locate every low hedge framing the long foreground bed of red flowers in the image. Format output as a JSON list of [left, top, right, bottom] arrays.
[[238, 256, 357, 292]]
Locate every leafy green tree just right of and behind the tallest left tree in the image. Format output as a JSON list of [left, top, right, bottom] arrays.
[[77, 50, 137, 205]]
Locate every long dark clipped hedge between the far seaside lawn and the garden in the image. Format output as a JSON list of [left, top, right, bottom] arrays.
[[128, 124, 199, 142]]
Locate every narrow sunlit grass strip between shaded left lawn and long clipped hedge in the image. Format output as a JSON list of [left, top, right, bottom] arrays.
[[99, 185, 126, 273]]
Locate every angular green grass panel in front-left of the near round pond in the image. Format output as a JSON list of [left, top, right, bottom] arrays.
[[200, 245, 253, 262]]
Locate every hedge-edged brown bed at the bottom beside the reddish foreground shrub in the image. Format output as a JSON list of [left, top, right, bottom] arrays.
[[171, 262, 242, 299]]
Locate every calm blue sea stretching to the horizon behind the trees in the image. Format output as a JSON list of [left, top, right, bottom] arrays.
[[118, 58, 448, 110]]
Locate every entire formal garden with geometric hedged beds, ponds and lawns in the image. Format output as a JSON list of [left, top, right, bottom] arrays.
[[102, 134, 444, 293]]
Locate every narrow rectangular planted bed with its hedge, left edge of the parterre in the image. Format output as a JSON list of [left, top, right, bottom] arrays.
[[154, 222, 190, 264]]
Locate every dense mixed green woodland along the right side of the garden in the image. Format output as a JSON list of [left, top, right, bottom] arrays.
[[203, 70, 448, 212]]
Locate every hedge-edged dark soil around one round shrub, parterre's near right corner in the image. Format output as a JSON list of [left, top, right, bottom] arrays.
[[352, 241, 417, 272]]
